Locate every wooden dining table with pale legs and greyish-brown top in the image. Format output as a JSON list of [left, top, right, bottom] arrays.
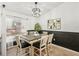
[[21, 34, 44, 56]]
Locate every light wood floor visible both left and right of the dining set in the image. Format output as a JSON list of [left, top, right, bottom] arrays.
[[2, 44, 79, 56]]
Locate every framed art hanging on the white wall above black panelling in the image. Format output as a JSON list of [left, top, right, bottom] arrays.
[[47, 18, 61, 30]]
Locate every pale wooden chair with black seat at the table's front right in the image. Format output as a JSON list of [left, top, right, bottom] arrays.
[[33, 35, 48, 56]]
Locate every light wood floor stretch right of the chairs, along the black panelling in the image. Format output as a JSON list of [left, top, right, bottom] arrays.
[[49, 44, 79, 56]]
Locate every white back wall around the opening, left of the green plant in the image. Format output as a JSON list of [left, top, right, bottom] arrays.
[[0, 8, 36, 34]]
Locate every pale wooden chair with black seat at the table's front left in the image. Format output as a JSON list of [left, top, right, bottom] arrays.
[[16, 35, 30, 55]]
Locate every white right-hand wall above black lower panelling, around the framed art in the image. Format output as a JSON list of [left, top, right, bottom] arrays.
[[40, 2, 79, 32]]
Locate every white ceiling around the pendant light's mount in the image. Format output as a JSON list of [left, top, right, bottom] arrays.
[[0, 2, 63, 16]]
